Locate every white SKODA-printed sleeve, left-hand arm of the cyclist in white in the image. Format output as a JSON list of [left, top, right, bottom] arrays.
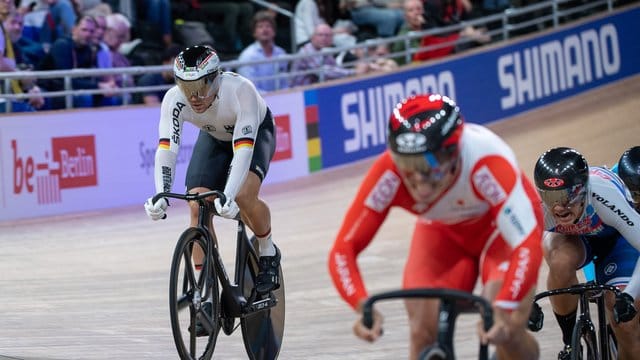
[[154, 87, 188, 193]]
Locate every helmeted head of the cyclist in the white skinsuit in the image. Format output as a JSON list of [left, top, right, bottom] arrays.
[[173, 45, 220, 98]]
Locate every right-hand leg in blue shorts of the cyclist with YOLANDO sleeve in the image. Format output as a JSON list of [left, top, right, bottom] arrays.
[[595, 236, 640, 360]]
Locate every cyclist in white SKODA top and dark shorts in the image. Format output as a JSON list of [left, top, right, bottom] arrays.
[[145, 46, 280, 292]]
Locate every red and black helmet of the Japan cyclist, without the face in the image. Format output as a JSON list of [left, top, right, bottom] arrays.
[[388, 94, 463, 155]]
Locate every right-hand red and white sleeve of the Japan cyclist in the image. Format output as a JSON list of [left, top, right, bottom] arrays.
[[473, 156, 543, 310]]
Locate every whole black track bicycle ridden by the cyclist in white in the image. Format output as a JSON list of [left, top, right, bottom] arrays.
[[153, 190, 285, 360]]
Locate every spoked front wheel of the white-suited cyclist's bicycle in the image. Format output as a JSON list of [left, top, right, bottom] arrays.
[[169, 228, 220, 360]]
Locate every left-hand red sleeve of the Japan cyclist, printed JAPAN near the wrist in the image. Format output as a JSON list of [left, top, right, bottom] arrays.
[[328, 152, 402, 309]]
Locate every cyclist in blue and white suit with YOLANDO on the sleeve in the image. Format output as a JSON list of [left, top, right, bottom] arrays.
[[534, 148, 640, 360]]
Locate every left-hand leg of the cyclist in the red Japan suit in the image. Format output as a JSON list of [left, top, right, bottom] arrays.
[[403, 221, 477, 359]]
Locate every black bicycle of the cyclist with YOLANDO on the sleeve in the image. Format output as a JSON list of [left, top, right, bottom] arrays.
[[529, 281, 620, 360]]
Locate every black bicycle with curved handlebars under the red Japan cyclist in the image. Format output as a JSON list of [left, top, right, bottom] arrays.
[[362, 288, 493, 360]]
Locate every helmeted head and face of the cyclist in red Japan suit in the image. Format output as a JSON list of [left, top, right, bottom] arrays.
[[388, 94, 464, 182]]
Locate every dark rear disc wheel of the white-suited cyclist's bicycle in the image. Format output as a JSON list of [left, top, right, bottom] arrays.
[[240, 237, 285, 360]]
